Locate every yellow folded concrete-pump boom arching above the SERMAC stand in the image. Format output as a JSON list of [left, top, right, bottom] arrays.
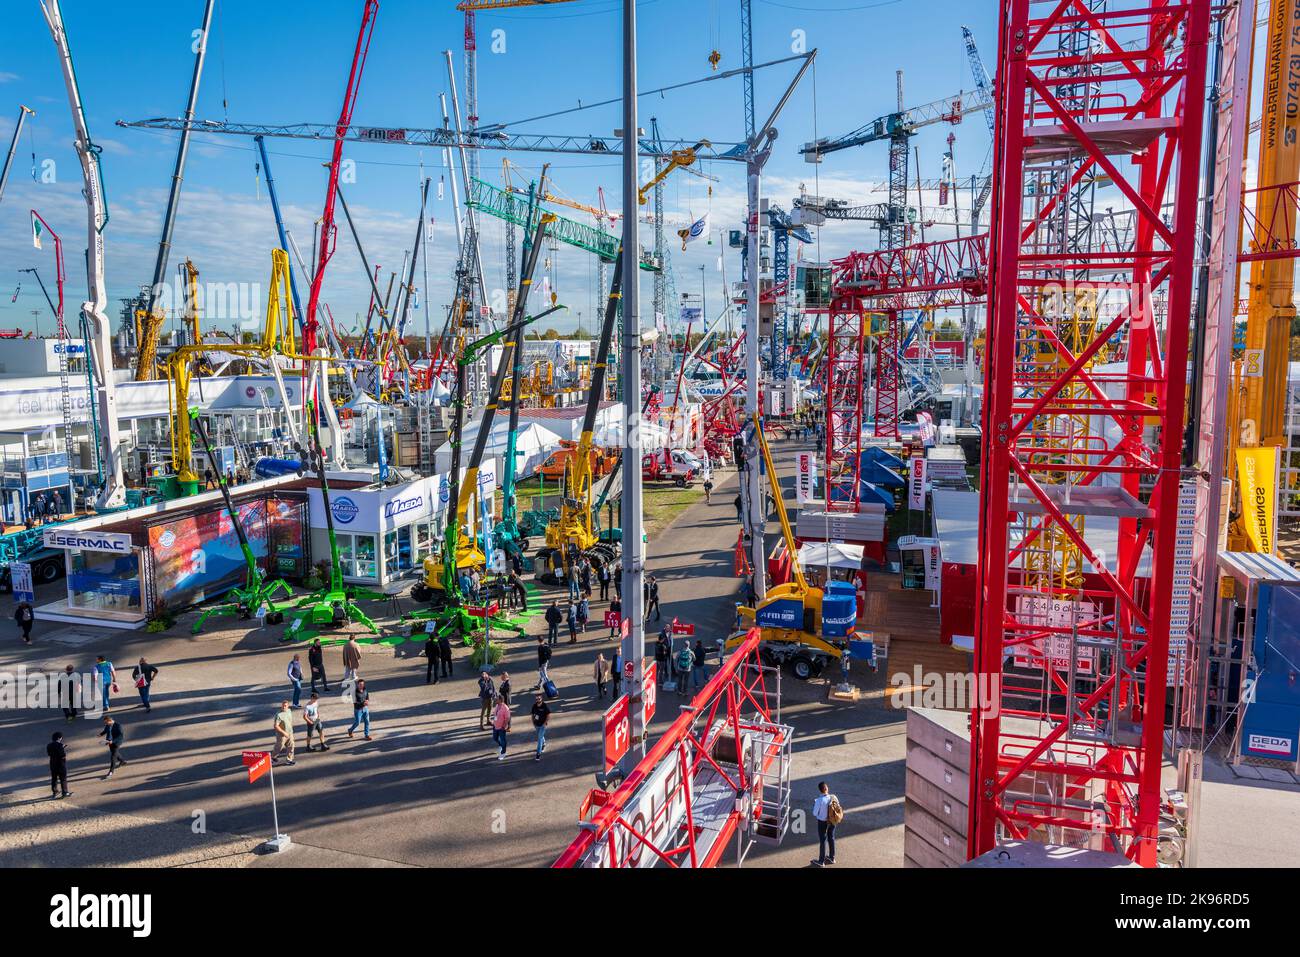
[[159, 248, 301, 498]]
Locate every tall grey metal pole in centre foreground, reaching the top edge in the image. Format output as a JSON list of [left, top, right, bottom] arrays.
[[615, 0, 646, 770]]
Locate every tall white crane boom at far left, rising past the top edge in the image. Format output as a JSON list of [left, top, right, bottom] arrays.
[[40, 0, 126, 511]]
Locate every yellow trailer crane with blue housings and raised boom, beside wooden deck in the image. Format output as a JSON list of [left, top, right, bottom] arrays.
[[723, 415, 858, 680]]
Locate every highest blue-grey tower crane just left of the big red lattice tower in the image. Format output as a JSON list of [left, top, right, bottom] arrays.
[[800, 80, 993, 248]]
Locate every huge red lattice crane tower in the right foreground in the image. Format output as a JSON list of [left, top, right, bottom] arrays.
[[969, 0, 1210, 866]]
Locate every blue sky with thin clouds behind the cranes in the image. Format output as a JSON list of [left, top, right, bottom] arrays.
[[0, 0, 996, 332]]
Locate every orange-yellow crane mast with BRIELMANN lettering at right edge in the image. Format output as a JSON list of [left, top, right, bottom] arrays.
[[1227, 0, 1300, 550]]
